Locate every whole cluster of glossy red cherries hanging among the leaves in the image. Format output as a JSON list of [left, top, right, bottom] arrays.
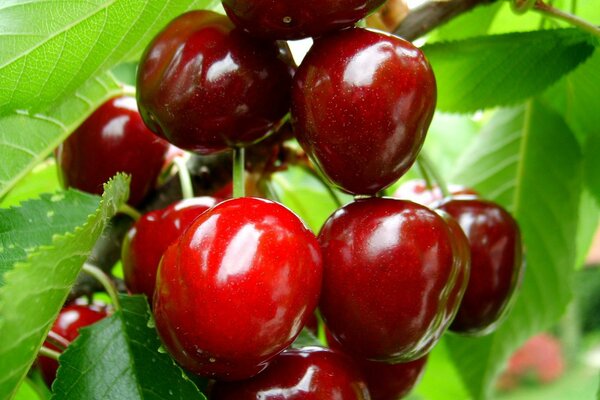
[[42, 0, 522, 400]]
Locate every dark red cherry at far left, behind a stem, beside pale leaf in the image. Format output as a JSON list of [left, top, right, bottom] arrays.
[[56, 96, 169, 205]]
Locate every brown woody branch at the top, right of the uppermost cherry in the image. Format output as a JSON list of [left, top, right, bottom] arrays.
[[393, 0, 496, 41]]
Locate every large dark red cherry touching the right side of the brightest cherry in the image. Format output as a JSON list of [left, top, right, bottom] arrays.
[[319, 198, 468, 363]]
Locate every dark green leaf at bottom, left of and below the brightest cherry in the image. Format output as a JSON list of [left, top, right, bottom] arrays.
[[52, 296, 206, 400]]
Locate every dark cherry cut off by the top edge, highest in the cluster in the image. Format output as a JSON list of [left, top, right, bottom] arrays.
[[223, 0, 385, 40]]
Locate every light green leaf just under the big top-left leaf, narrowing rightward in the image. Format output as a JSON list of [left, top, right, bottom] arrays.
[[0, 71, 123, 197]]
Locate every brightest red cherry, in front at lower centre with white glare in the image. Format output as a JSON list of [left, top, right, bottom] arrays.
[[154, 197, 322, 380]]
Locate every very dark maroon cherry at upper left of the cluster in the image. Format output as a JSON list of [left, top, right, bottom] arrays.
[[137, 11, 292, 154]]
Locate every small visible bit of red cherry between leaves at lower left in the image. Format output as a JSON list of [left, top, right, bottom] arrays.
[[38, 304, 107, 387]]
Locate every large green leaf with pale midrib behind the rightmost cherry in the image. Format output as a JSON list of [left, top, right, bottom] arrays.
[[447, 101, 583, 398]]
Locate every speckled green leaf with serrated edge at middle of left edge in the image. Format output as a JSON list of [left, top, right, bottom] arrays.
[[0, 190, 99, 287]]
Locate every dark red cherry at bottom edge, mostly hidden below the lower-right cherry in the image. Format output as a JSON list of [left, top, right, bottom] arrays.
[[325, 329, 429, 400]]
